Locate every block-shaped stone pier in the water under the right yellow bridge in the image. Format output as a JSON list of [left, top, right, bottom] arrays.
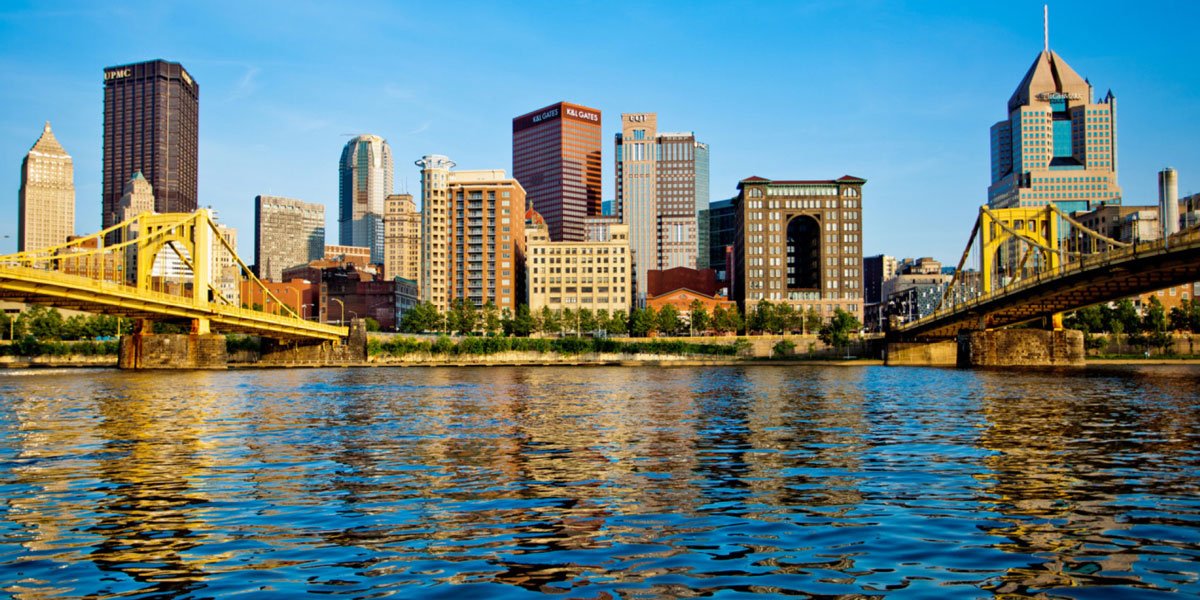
[[958, 329, 1085, 367]]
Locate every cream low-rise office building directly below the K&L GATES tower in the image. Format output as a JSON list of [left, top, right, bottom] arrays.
[[526, 211, 634, 313]]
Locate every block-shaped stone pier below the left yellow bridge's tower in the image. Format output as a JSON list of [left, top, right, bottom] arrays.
[[118, 332, 228, 370]]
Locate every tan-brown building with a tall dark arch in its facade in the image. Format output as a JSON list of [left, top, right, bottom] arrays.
[[730, 175, 866, 320]]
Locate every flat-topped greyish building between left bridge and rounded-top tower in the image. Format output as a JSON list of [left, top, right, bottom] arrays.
[[254, 196, 325, 281]]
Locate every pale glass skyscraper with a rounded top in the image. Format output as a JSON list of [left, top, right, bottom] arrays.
[[337, 134, 392, 264]]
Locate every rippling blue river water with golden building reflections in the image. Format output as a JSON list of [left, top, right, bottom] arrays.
[[0, 366, 1200, 599]]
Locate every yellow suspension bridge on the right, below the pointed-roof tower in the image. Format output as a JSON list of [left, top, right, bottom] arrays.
[[888, 204, 1200, 350]]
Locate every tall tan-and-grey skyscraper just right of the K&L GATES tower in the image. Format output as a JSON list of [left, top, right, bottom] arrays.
[[616, 113, 708, 301]]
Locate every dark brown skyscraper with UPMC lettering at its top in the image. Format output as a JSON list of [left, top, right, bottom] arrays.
[[102, 60, 200, 227]]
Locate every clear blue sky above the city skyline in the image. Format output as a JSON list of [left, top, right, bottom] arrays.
[[0, 0, 1200, 262]]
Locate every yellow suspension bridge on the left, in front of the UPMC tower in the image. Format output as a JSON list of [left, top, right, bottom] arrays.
[[0, 209, 349, 341]]
